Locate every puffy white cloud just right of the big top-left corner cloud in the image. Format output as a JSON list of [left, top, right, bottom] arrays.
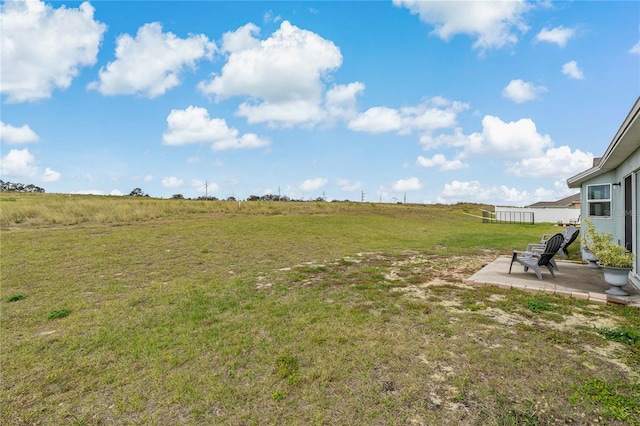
[[88, 22, 216, 98]]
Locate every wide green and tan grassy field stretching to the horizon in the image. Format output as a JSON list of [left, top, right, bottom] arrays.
[[0, 193, 640, 425]]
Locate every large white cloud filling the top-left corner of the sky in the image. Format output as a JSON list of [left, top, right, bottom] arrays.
[[0, 1, 107, 103]]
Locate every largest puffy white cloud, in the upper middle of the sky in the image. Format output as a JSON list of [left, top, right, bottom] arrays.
[[198, 21, 342, 126]]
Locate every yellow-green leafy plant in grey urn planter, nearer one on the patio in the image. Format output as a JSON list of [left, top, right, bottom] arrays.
[[594, 231, 634, 296]]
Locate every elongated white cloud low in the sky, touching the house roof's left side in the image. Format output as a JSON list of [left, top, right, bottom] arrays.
[[506, 146, 593, 178]]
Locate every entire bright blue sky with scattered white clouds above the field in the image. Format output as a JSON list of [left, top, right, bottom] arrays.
[[0, 0, 640, 206]]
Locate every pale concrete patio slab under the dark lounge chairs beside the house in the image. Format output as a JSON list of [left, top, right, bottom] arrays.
[[463, 256, 640, 308]]
